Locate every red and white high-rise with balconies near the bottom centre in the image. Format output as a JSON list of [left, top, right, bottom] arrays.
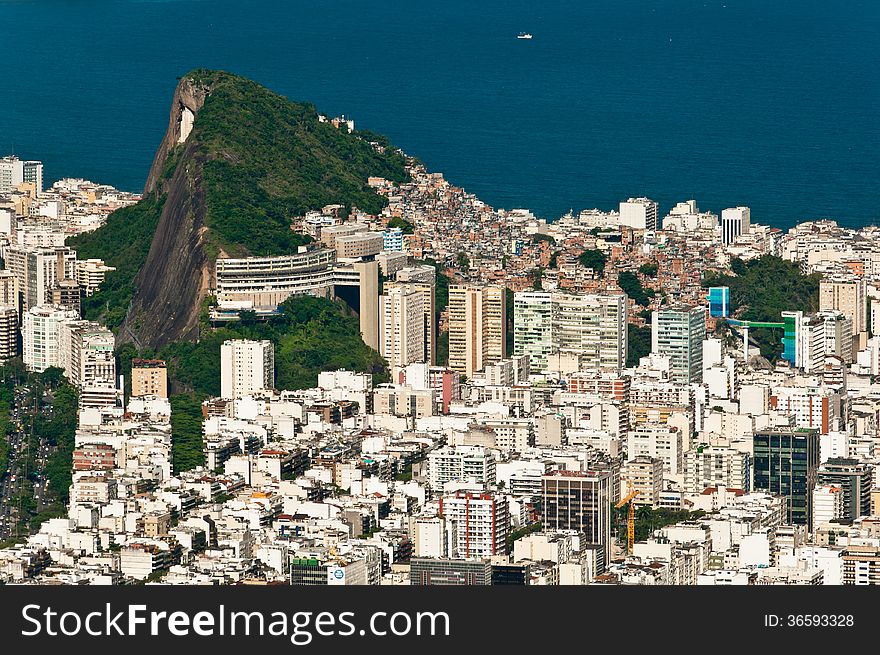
[[440, 492, 510, 559]]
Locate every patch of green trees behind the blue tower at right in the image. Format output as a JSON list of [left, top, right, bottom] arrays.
[[703, 255, 821, 361]]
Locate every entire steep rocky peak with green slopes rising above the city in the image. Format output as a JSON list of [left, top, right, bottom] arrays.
[[70, 70, 406, 349]]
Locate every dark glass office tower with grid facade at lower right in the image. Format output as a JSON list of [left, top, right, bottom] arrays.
[[753, 428, 819, 530]]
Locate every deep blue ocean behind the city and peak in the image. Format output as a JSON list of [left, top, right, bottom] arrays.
[[0, 0, 880, 228]]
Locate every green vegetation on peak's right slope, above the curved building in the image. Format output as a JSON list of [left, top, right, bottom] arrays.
[[189, 71, 406, 255]]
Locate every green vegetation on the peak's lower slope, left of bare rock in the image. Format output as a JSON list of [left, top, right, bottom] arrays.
[[67, 194, 164, 329]]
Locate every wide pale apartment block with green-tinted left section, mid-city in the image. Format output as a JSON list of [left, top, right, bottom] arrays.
[[514, 291, 627, 373]]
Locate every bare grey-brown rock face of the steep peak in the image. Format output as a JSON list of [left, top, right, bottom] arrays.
[[119, 78, 211, 348]]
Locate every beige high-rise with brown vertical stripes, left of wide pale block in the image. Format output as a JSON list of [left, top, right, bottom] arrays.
[[448, 285, 507, 377]]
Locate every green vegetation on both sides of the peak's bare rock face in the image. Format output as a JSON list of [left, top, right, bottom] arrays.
[[68, 70, 407, 329]]
